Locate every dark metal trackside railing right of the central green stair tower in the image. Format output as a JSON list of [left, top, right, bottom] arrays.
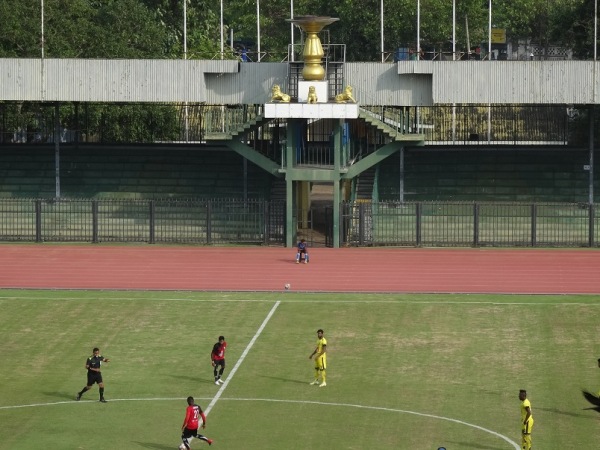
[[340, 202, 600, 247]]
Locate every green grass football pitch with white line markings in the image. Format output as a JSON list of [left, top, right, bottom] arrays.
[[0, 290, 600, 450]]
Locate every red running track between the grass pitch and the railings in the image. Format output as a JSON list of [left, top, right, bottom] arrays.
[[0, 244, 600, 294]]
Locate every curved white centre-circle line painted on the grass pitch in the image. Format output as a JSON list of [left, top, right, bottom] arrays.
[[0, 396, 520, 450]]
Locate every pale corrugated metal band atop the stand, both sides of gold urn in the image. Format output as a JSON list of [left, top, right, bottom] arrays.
[[0, 59, 600, 106]]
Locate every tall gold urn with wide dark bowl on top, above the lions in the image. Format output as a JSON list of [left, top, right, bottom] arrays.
[[286, 16, 340, 81]]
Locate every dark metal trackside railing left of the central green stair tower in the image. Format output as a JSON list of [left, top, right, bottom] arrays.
[[0, 199, 285, 244]]
